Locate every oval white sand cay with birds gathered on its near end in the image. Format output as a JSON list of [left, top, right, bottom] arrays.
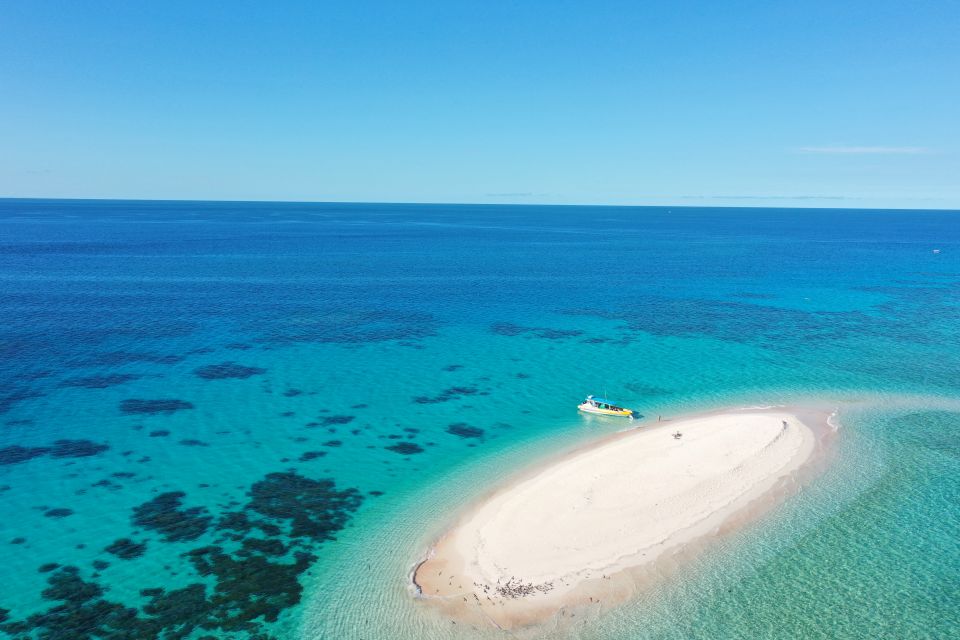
[[414, 409, 825, 628]]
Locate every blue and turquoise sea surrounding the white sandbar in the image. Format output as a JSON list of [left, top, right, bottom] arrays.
[[0, 200, 960, 640]]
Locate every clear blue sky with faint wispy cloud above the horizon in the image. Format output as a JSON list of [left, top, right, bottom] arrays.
[[0, 0, 960, 209]]
